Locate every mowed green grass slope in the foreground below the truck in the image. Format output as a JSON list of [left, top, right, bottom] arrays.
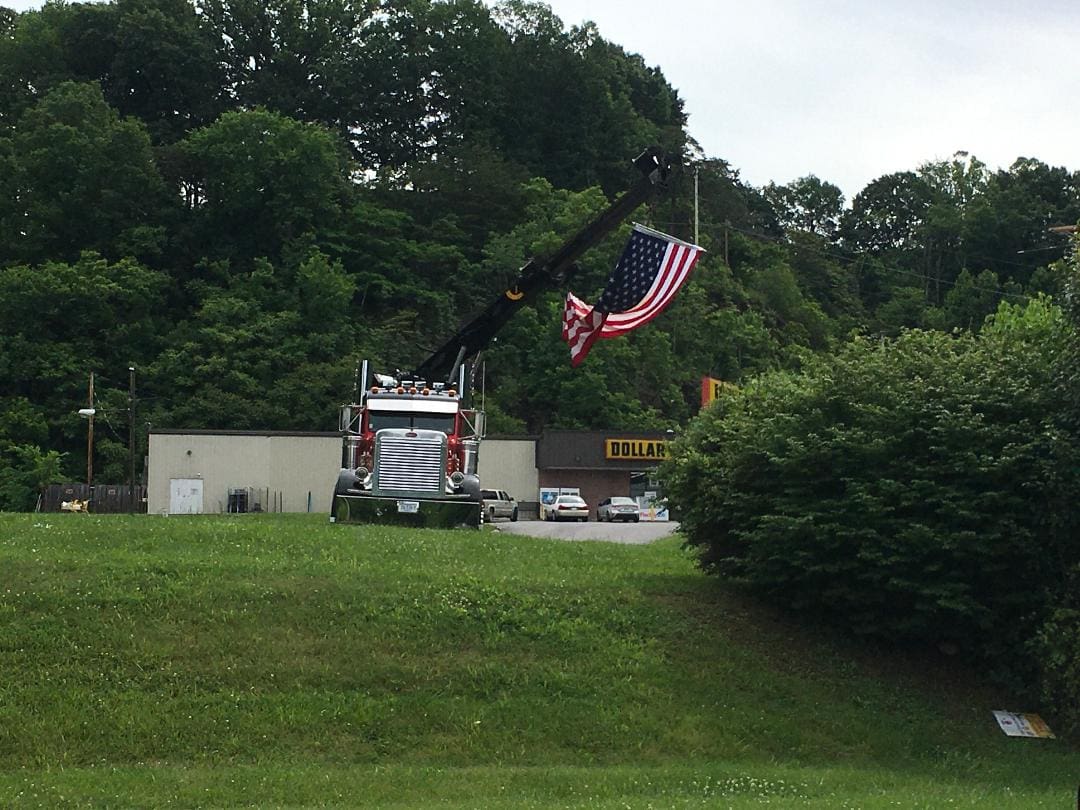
[[0, 514, 1080, 809]]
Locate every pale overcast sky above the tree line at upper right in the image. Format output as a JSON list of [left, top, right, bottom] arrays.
[[8, 0, 1080, 200]]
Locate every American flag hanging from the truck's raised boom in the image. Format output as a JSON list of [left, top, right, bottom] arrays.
[[563, 224, 702, 366]]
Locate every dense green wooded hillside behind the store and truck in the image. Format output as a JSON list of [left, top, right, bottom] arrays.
[[0, 0, 1080, 509]]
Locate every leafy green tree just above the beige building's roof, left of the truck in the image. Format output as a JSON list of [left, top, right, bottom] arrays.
[[147, 251, 362, 430]]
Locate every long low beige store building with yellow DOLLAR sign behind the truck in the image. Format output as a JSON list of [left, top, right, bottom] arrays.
[[147, 430, 670, 518]]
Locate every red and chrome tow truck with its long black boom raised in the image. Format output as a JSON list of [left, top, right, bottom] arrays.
[[330, 147, 672, 527]]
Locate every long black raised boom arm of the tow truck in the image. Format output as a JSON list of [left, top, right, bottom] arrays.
[[416, 147, 671, 381]]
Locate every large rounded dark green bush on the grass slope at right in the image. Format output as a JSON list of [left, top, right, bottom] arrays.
[[661, 300, 1078, 660]]
